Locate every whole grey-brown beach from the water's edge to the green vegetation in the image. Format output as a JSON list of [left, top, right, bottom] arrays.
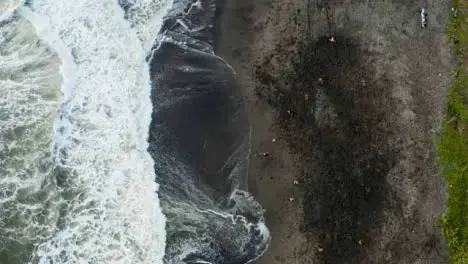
[[216, 0, 451, 264]]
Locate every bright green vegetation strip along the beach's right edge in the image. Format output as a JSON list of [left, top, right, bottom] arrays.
[[437, 0, 468, 264]]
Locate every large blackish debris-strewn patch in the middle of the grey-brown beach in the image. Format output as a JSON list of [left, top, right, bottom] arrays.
[[255, 36, 398, 264]]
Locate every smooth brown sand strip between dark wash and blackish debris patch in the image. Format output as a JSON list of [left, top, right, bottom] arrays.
[[216, 1, 318, 264]]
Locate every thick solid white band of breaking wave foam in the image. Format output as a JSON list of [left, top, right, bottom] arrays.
[[22, 0, 170, 264]]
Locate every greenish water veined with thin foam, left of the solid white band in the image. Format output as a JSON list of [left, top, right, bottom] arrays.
[[0, 12, 62, 254]]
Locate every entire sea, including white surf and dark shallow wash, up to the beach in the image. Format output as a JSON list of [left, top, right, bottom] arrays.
[[0, 0, 270, 264]]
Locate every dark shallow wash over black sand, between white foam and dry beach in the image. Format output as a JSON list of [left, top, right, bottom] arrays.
[[150, 0, 270, 264]]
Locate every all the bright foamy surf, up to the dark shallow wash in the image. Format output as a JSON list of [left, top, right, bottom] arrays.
[[0, 0, 165, 264]]
